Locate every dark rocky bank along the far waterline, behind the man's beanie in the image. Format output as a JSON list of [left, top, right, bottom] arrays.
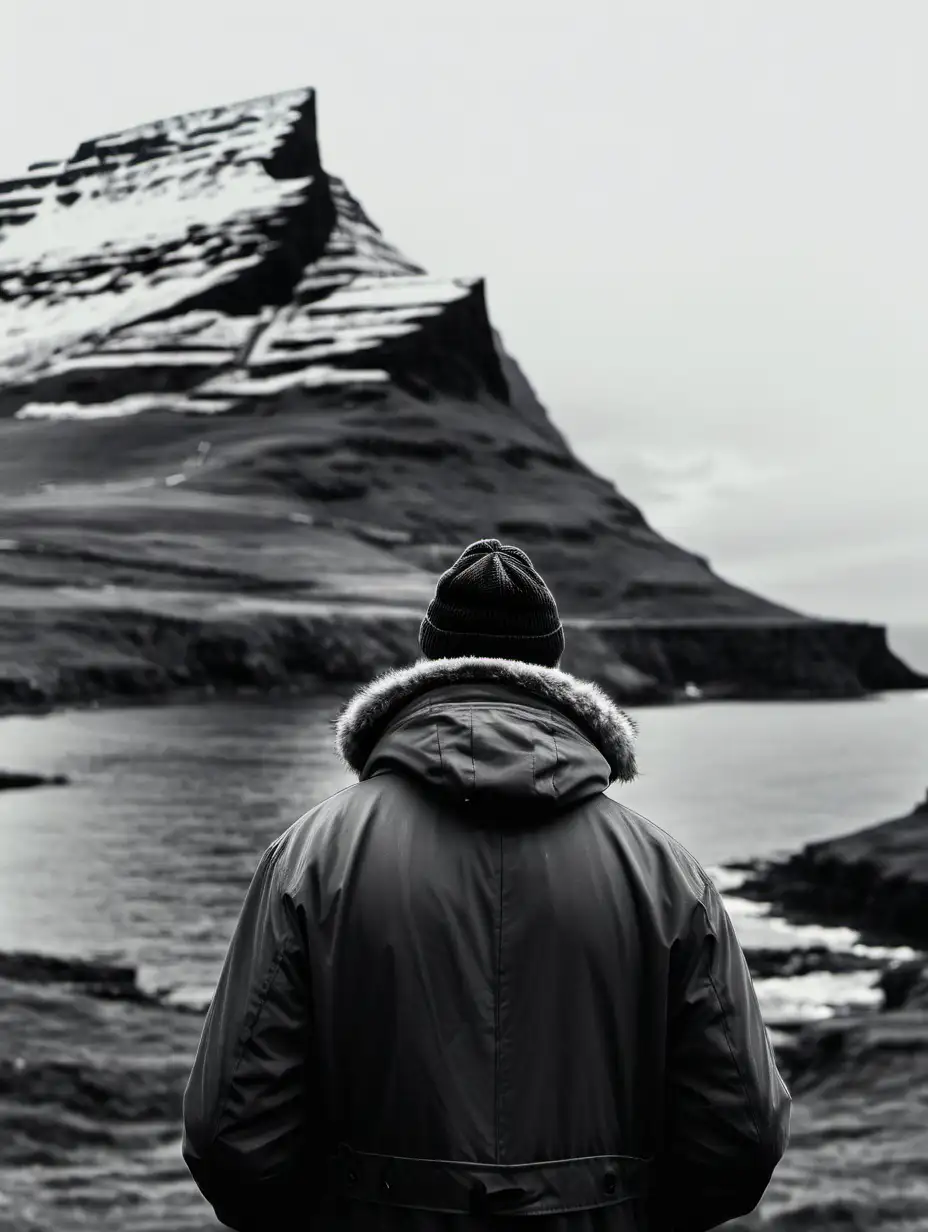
[[0, 599, 674, 713]]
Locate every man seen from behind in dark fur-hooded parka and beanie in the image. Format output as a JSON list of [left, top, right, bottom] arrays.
[[184, 540, 790, 1232]]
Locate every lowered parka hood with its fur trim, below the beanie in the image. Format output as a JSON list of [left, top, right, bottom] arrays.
[[335, 657, 637, 811]]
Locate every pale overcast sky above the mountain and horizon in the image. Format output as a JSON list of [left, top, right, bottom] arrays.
[[0, 0, 928, 625]]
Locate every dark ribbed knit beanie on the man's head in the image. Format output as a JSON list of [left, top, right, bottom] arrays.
[[419, 540, 564, 668]]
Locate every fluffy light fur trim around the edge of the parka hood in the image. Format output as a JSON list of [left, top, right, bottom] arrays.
[[335, 655, 637, 782]]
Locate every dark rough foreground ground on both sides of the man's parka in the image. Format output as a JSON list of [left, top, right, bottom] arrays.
[[0, 793, 928, 1232]]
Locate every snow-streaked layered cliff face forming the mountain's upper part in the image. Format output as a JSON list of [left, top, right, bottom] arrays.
[[0, 90, 507, 419]]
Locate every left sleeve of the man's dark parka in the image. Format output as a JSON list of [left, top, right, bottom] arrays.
[[181, 844, 320, 1232]]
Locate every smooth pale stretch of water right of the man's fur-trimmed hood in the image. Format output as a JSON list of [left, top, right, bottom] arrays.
[[610, 691, 928, 865]]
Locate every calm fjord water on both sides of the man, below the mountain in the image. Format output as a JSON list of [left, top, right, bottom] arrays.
[[0, 692, 928, 1004]]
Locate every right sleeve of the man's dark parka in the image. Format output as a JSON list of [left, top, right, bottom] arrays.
[[657, 878, 791, 1232]]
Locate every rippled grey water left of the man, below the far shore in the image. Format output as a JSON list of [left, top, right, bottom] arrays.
[[0, 697, 350, 999]]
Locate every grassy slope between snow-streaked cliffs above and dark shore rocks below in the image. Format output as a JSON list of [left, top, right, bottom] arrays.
[[0, 367, 786, 616]]
